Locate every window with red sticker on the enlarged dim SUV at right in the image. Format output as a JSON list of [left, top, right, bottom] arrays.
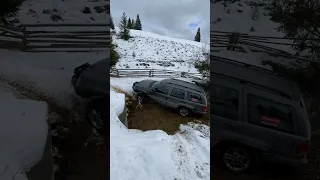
[[247, 94, 294, 133]]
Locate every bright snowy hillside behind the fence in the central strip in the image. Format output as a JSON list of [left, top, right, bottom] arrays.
[[113, 28, 209, 72]]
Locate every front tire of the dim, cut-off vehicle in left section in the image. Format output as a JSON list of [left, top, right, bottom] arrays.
[[86, 99, 109, 134]]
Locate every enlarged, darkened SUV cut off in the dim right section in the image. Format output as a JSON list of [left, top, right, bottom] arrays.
[[210, 56, 311, 172]]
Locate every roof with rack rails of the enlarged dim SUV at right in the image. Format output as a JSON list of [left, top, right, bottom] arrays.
[[210, 56, 300, 100]]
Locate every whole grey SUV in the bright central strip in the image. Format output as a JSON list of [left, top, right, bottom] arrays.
[[132, 79, 207, 116]]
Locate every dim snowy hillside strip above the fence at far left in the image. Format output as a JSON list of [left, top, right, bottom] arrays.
[[12, 0, 109, 24]]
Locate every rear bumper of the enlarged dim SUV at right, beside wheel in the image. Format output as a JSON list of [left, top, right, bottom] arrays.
[[263, 153, 308, 166]]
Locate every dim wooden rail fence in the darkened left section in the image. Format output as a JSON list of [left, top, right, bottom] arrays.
[[0, 23, 111, 52]]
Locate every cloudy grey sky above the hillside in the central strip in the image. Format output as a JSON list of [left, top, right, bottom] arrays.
[[110, 0, 210, 43]]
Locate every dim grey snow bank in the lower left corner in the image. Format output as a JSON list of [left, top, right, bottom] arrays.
[[0, 88, 48, 179]]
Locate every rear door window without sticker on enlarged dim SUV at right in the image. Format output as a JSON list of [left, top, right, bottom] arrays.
[[210, 84, 239, 120]]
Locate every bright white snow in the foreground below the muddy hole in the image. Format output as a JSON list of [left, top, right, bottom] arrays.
[[110, 88, 210, 180]]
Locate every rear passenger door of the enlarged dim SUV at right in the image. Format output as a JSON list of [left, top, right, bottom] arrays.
[[210, 77, 242, 141]]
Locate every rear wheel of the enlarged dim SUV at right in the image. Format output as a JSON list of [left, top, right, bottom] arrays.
[[220, 144, 259, 174]]
